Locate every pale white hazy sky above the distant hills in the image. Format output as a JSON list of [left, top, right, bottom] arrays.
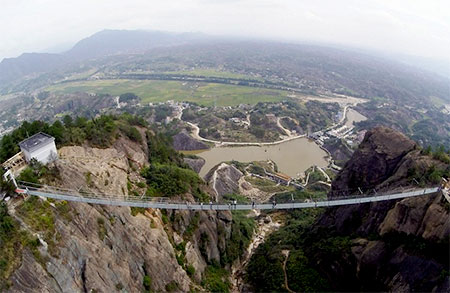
[[0, 0, 450, 59]]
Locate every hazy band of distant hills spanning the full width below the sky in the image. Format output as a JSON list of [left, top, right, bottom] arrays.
[[0, 30, 450, 103]]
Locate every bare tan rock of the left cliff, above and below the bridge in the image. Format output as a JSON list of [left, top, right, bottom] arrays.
[[5, 133, 231, 292]]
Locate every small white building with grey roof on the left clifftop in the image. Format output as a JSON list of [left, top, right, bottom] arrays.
[[19, 132, 58, 164]]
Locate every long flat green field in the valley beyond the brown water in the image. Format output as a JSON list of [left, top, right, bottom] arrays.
[[46, 79, 288, 106]]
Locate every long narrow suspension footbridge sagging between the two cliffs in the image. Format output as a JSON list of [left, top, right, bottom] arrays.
[[16, 181, 449, 210]]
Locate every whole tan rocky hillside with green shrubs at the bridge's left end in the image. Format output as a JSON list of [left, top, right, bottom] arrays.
[[0, 116, 253, 292]]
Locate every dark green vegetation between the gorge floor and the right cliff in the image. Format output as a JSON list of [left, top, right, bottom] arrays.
[[246, 191, 328, 292]]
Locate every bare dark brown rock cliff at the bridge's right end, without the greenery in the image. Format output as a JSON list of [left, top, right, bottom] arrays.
[[314, 127, 450, 292]]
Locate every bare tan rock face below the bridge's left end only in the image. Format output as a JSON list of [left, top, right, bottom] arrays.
[[11, 203, 191, 292]]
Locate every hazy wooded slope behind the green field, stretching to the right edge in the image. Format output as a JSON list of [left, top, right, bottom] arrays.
[[117, 41, 449, 101]]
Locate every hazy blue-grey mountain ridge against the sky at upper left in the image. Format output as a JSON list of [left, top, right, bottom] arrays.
[[0, 30, 207, 82]]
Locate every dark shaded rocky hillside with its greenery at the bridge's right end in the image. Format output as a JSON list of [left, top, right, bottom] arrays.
[[247, 127, 450, 292]]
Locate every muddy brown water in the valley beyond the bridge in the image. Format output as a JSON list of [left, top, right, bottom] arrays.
[[186, 138, 328, 177]]
